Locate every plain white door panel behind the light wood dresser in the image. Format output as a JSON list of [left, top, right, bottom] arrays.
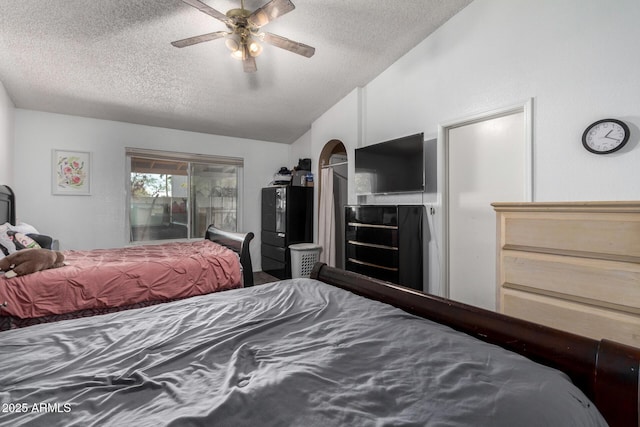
[[445, 107, 531, 310]]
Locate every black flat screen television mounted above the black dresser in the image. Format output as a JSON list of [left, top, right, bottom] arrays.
[[355, 133, 424, 195]]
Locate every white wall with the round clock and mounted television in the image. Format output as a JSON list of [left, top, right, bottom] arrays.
[[294, 0, 640, 298]]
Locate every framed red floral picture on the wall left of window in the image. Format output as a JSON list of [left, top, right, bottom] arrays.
[[51, 150, 91, 196]]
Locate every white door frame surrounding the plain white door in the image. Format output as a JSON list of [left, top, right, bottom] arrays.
[[438, 98, 534, 298]]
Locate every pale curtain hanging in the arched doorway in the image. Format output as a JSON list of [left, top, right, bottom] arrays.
[[318, 167, 336, 267]]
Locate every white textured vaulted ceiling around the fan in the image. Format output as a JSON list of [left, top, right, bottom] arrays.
[[0, 0, 471, 143]]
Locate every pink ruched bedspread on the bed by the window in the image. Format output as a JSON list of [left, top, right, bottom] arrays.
[[0, 240, 242, 319]]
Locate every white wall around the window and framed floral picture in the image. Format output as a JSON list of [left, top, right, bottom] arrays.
[[14, 109, 291, 270]]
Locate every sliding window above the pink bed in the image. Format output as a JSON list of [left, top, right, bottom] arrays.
[[126, 148, 243, 242]]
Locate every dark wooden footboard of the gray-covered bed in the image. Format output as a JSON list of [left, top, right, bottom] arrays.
[[311, 263, 640, 426]]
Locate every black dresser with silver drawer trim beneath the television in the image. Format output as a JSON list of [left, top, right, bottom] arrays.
[[345, 205, 424, 291]]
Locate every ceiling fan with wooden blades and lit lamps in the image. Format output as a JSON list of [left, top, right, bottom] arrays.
[[171, 0, 316, 73]]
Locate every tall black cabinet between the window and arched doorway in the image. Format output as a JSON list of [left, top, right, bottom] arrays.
[[260, 186, 313, 279]]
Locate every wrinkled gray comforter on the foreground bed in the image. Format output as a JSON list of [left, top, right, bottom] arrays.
[[0, 279, 605, 427]]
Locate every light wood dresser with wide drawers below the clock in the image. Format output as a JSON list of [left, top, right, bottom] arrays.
[[493, 201, 640, 347]]
